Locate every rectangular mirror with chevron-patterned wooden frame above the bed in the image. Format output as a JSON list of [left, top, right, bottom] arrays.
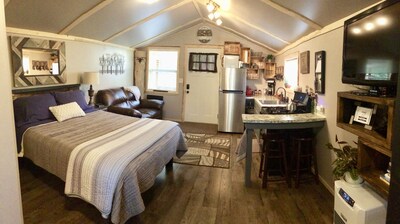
[[10, 36, 66, 87]]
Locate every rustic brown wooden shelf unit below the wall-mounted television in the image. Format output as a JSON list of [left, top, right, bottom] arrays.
[[337, 92, 395, 198]]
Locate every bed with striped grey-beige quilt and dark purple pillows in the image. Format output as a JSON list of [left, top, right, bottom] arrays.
[[14, 87, 187, 223]]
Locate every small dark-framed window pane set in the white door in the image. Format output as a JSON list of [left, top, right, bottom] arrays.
[[189, 53, 218, 73]]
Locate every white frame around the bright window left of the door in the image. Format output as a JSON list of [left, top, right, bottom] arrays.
[[145, 47, 181, 94]]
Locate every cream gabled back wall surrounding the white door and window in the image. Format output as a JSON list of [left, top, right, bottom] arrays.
[[141, 23, 271, 121]]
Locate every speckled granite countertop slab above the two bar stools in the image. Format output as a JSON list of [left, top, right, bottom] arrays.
[[242, 113, 326, 124]]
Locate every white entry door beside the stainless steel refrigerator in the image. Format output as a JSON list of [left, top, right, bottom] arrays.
[[184, 47, 223, 124]]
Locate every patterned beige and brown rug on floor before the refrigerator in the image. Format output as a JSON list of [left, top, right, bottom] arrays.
[[174, 133, 231, 169]]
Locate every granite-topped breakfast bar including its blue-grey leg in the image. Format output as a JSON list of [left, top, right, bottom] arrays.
[[242, 113, 326, 187]]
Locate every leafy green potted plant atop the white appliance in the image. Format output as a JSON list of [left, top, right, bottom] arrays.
[[326, 136, 358, 180]]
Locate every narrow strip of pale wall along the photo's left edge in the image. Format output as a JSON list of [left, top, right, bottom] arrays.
[[0, 1, 24, 224]]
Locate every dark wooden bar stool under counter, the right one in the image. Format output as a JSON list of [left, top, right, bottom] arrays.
[[291, 132, 319, 188]]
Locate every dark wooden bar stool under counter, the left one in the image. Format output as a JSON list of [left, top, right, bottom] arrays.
[[259, 132, 291, 188]]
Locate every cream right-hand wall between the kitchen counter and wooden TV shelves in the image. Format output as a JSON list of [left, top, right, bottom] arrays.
[[276, 27, 357, 192]]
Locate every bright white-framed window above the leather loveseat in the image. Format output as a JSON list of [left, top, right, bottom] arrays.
[[146, 48, 179, 93]]
